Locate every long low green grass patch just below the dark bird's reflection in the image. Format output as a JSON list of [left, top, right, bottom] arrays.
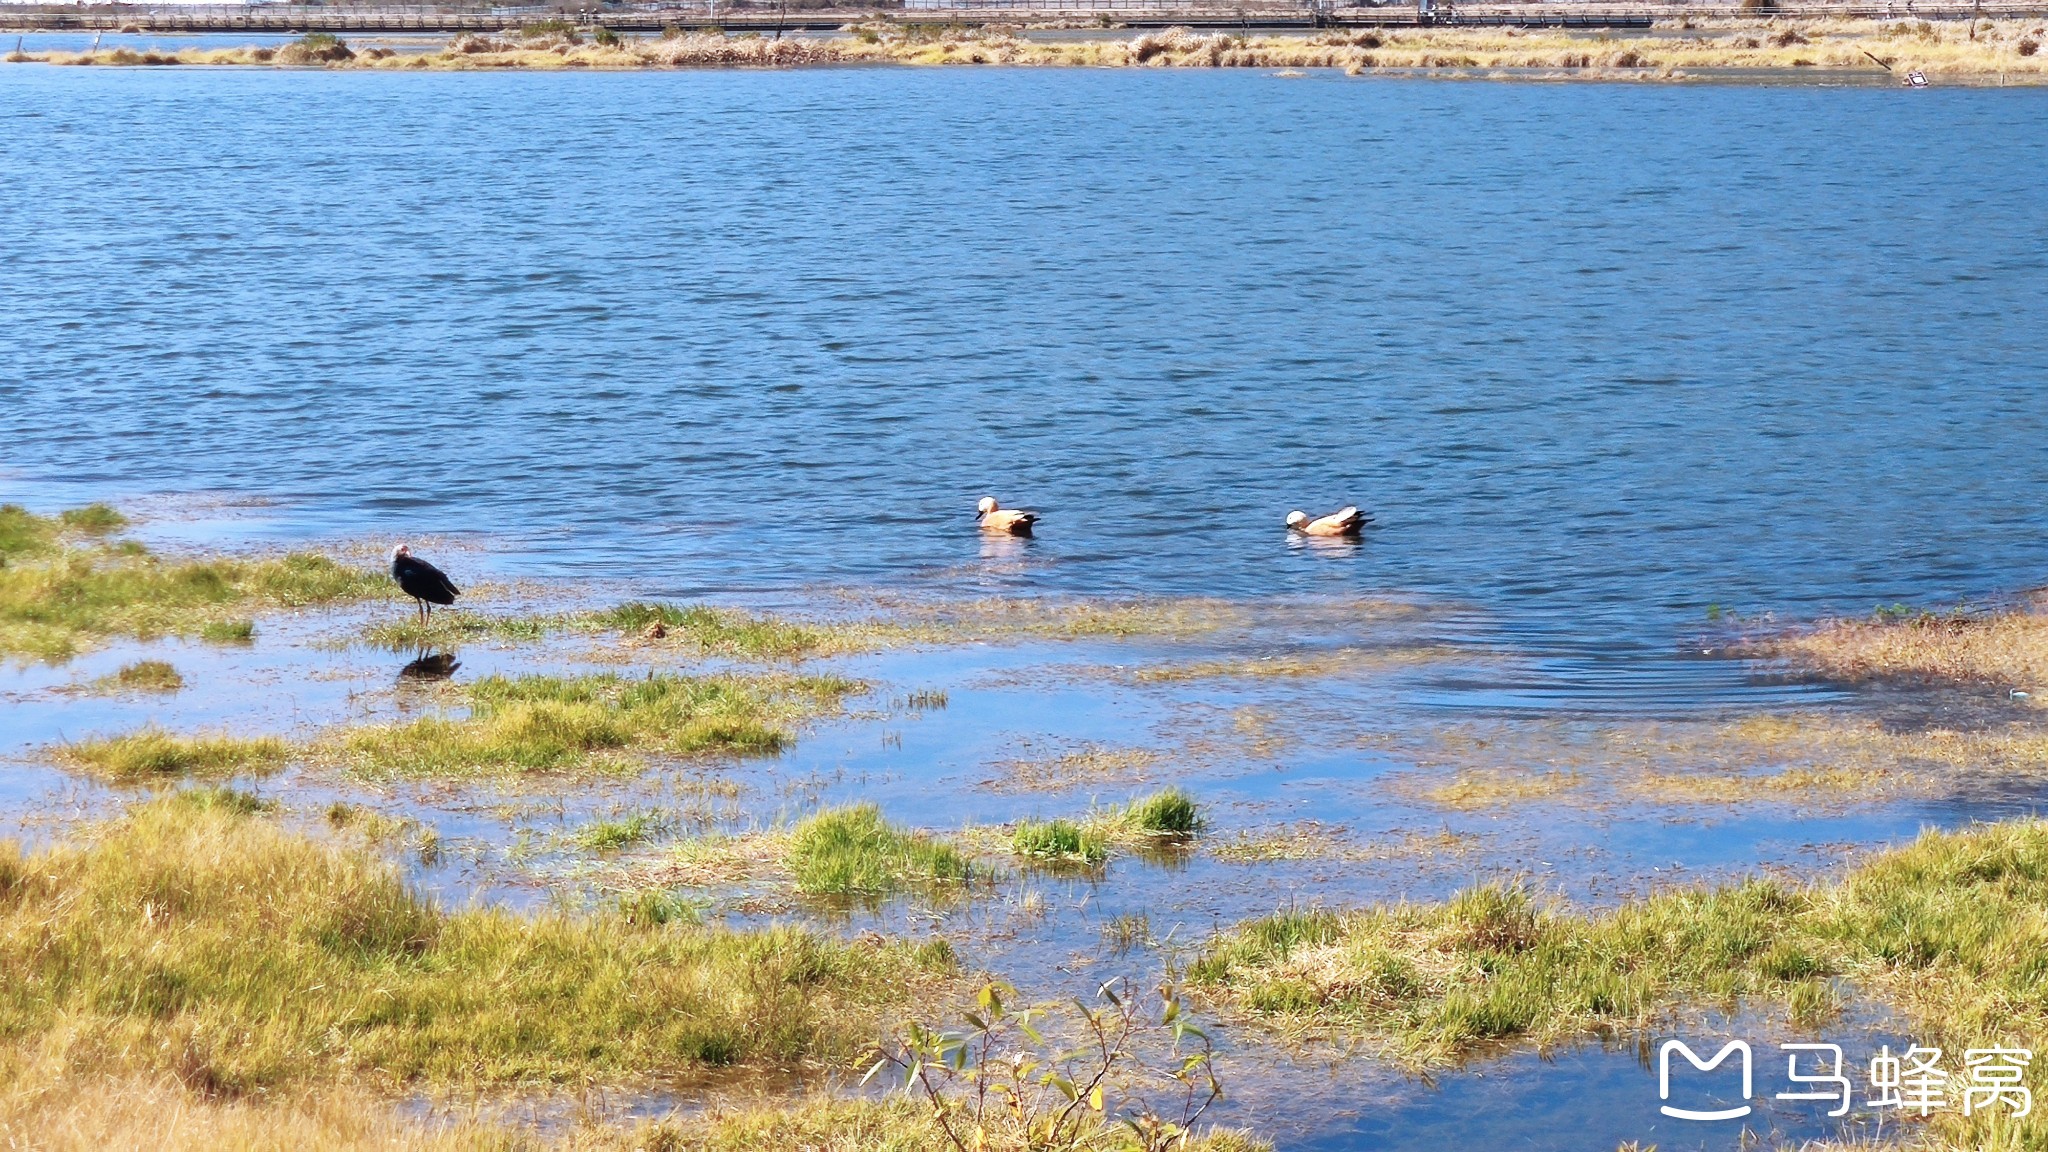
[[338, 674, 862, 777]]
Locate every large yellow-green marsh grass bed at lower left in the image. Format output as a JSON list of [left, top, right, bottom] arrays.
[[0, 801, 952, 1095]]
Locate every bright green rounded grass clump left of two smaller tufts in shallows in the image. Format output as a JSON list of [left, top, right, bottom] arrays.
[[782, 804, 975, 896]]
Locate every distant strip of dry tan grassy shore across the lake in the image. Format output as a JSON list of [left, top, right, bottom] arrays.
[[6, 18, 2048, 86]]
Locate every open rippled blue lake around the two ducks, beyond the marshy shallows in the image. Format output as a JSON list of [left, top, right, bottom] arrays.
[[0, 66, 2048, 654]]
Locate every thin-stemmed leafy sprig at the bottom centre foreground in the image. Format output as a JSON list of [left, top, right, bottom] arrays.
[[866, 980, 1231, 1152]]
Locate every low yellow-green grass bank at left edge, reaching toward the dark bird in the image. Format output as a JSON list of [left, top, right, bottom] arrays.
[[0, 504, 391, 660]]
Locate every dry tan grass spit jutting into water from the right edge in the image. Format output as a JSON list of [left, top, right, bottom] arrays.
[[1743, 611, 2048, 689]]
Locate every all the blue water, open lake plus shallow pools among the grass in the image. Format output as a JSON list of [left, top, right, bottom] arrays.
[[0, 68, 2048, 1148]]
